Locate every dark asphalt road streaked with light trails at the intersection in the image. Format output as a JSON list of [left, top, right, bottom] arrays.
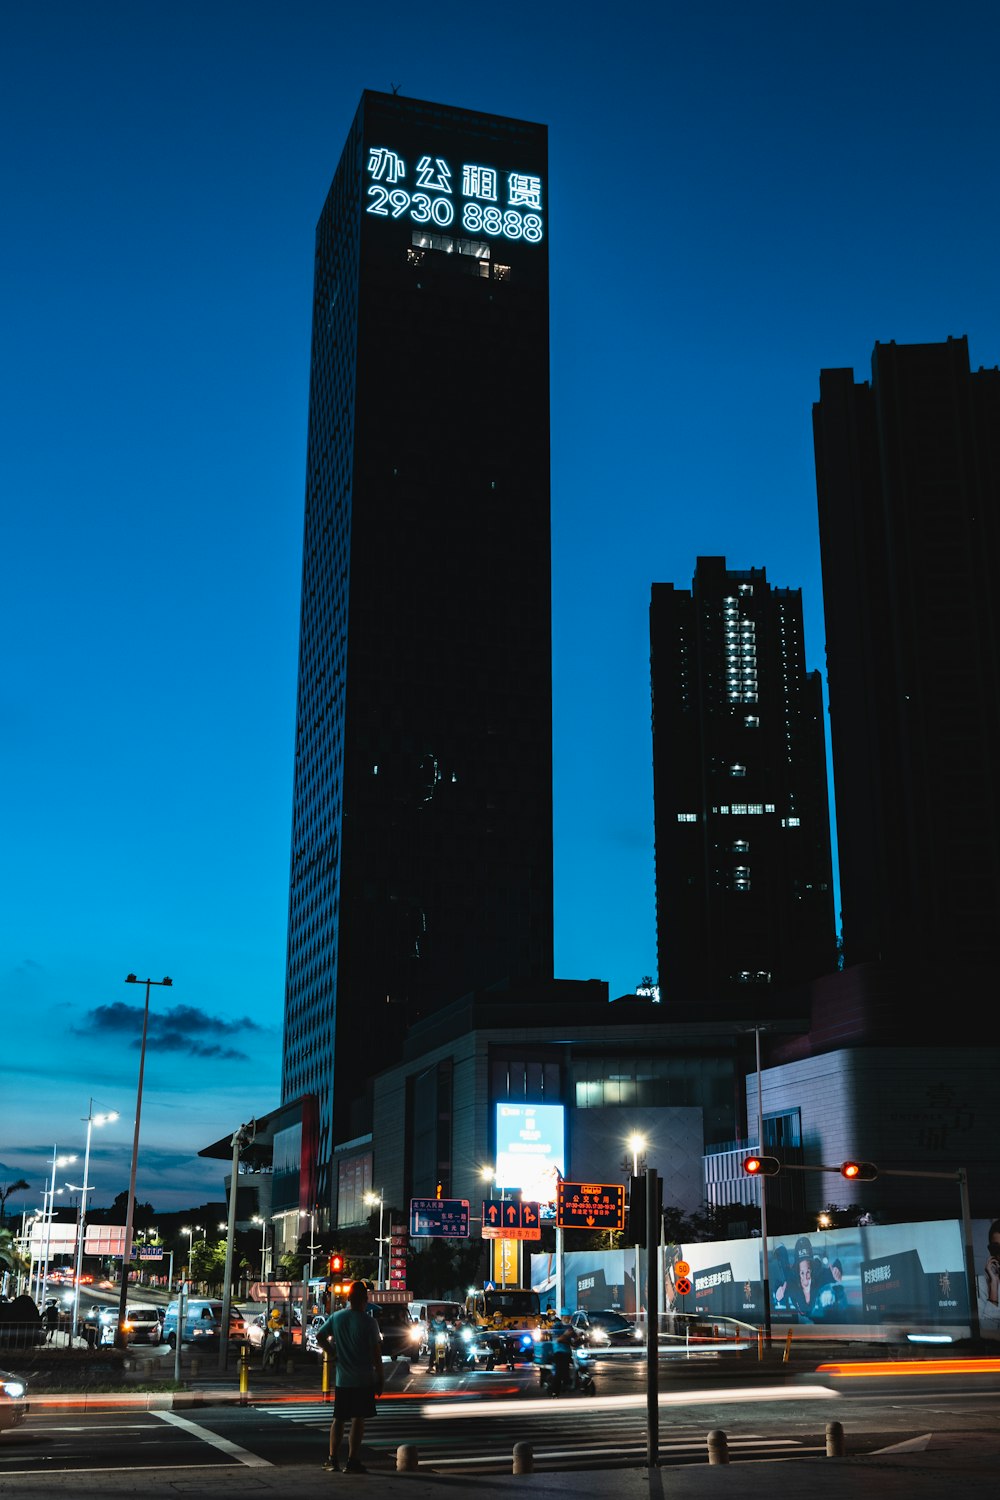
[[7, 1361, 1000, 1493]]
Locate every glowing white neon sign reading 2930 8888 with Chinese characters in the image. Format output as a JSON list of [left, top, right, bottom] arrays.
[[364, 146, 544, 245]]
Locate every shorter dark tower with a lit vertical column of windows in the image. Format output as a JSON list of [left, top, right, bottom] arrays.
[[649, 558, 835, 1019]]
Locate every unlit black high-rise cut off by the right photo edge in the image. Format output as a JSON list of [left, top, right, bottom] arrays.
[[814, 338, 1000, 996]]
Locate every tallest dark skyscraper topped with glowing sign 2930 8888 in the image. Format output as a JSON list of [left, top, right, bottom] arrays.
[[282, 92, 552, 1205]]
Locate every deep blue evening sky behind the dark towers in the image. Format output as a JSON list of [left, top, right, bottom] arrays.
[[0, 0, 1000, 1209]]
